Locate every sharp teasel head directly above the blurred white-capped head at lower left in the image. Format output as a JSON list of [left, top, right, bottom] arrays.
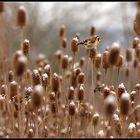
[[32, 69, 41, 86]]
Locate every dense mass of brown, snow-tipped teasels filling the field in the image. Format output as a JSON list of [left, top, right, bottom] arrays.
[[0, 2, 140, 138]]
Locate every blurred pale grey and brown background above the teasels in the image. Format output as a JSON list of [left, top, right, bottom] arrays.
[[1, 2, 137, 70]]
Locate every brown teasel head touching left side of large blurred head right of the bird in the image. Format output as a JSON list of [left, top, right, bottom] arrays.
[[102, 51, 109, 69]]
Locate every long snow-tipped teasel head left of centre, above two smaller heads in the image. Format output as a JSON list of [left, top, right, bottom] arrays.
[[52, 73, 60, 92]]
